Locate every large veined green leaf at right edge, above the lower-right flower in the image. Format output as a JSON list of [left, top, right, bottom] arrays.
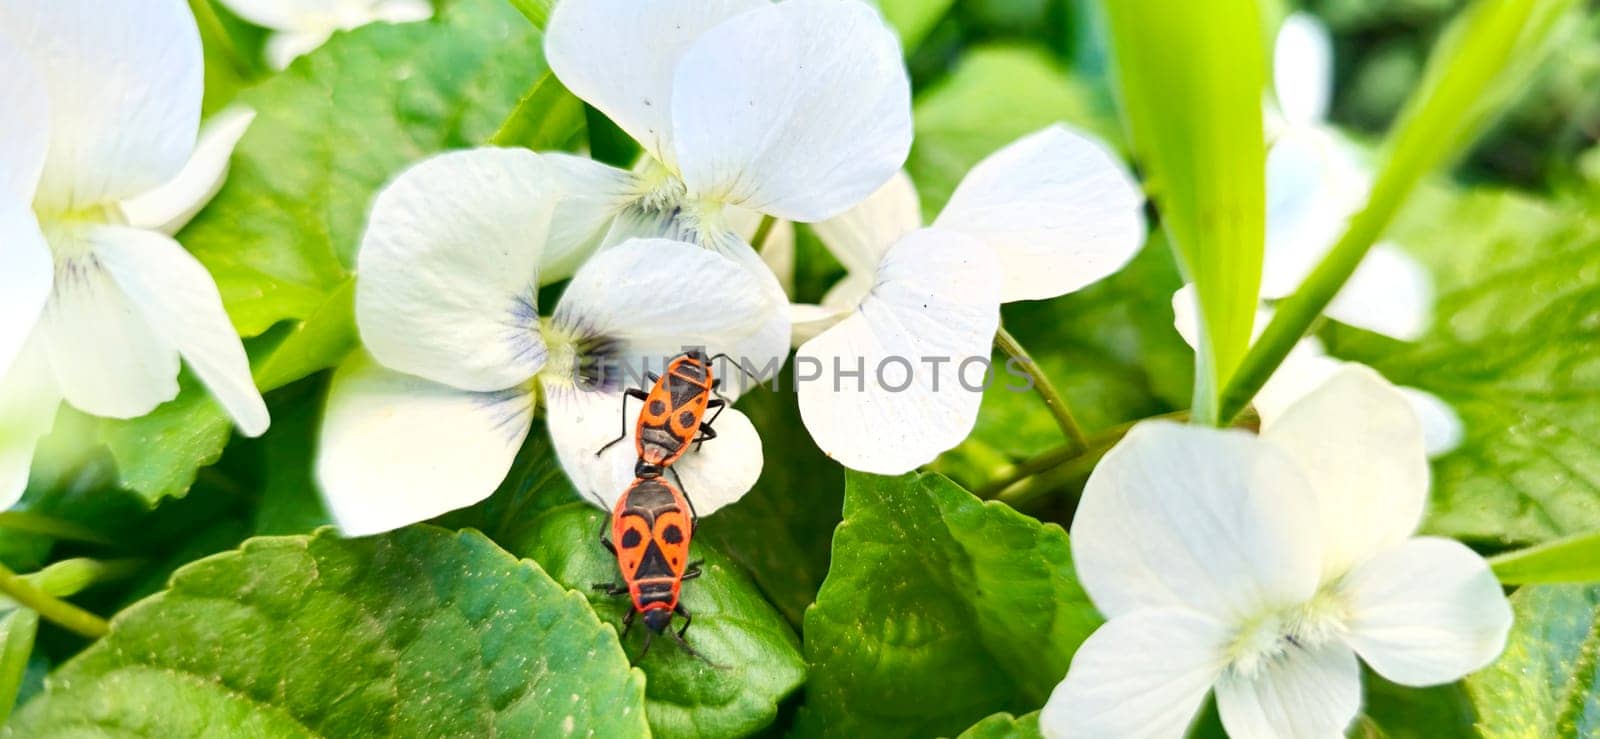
[[1323, 190, 1600, 547]]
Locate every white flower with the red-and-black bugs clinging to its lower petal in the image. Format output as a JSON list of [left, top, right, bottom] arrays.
[[317, 149, 766, 536]]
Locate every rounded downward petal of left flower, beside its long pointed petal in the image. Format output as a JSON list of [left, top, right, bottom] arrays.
[[40, 230, 178, 419]]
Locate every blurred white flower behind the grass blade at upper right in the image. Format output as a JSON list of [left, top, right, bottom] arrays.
[[1261, 13, 1434, 341]]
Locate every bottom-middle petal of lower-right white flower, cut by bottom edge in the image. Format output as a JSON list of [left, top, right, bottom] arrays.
[[1216, 643, 1362, 739]]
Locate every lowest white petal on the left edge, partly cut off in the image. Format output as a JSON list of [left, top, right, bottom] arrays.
[[0, 333, 61, 510]]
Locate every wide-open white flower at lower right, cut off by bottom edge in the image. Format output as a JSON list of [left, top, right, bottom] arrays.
[[1040, 366, 1512, 739]]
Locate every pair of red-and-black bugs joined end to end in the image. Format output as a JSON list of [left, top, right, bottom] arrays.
[[595, 350, 728, 661]]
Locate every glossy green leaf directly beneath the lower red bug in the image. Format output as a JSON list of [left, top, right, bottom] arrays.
[[510, 496, 805, 736]]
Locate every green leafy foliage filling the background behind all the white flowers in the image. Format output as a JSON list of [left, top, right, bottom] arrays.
[[0, 0, 1600, 737]]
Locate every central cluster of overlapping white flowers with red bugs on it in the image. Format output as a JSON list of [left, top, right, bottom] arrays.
[[305, 0, 1144, 534]]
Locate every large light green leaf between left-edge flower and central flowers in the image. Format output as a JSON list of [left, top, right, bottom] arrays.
[[102, 0, 581, 502]]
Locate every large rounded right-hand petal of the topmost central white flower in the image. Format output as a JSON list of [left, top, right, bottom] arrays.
[[668, 0, 912, 222]]
